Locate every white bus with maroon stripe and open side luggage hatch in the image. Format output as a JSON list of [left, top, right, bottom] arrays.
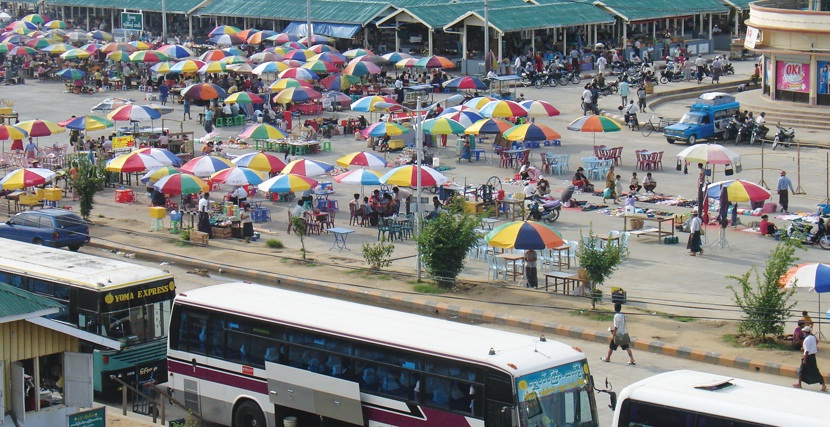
[[168, 283, 598, 427]]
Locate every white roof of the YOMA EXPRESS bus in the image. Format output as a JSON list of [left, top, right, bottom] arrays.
[[0, 238, 173, 291]]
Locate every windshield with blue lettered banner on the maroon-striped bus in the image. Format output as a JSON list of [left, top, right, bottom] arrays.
[[517, 360, 598, 427]]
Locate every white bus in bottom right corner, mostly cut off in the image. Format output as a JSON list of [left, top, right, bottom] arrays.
[[612, 371, 830, 427]]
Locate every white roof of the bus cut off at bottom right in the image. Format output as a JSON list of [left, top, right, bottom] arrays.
[[619, 370, 829, 427]]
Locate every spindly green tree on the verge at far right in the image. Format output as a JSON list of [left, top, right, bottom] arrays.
[[728, 240, 799, 340]]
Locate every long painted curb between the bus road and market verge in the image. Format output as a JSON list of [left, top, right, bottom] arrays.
[[87, 242, 830, 384]]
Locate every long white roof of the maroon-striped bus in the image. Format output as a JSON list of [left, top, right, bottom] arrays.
[[176, 283, 585, 376]]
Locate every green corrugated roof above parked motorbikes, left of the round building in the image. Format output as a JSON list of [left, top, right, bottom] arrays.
[[592, 0, 728, 21]]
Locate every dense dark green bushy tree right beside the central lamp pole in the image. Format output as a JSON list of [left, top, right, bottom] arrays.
[[416, 198, 485, 289]]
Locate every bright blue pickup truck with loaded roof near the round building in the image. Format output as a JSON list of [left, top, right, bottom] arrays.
[[664, 92, 740, 144]]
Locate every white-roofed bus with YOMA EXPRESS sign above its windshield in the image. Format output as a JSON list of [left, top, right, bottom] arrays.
[[0, 239, 176, 394]]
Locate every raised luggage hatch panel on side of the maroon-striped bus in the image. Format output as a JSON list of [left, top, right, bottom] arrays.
[[266, 361, 365, 425]]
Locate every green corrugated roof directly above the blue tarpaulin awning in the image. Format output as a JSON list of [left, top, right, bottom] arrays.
[[201, 0, 392, 25]]
